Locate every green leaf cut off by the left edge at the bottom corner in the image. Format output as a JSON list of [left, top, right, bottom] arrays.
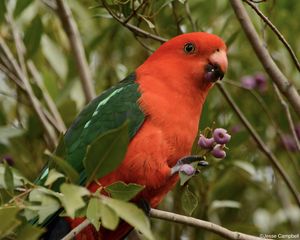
[[0, 206, 21, 237]]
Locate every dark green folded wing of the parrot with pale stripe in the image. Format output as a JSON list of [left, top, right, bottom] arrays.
[[64, 71, 145, 172]]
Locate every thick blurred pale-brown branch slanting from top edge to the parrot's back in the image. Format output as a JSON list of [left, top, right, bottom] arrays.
[[56, 0, 96, 103]]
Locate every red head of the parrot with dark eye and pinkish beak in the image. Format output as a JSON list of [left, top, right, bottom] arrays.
[[143, 32, 228, 91]]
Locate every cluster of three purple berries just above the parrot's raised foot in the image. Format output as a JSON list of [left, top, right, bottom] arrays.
[[198, 128, 231, 158]]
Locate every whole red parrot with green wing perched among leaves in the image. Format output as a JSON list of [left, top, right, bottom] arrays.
[[44, 32, 228, 240]]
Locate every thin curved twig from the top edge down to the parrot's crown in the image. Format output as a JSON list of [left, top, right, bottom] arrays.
[[101, 0, 167, 43]]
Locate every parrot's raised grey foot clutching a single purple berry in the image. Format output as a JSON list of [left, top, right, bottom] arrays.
[[171, 155, 209, 175]]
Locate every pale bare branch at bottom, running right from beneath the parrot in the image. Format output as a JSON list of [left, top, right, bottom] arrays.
[[149, 208, 268, 240]]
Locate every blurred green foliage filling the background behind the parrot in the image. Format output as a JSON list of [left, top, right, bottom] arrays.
[[0, 0, 300, 240]]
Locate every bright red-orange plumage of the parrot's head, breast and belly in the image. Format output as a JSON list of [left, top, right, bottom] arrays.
[[70, 32, 227, 240]]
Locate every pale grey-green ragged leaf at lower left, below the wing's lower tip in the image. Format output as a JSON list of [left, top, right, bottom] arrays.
[[27, 187, 60, 224]]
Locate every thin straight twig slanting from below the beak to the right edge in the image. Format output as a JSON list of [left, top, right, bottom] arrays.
[[217, 83, 300, 207]]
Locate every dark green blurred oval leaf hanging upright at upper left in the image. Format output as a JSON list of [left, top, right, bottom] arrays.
[[24, 15, 43, 57]]
